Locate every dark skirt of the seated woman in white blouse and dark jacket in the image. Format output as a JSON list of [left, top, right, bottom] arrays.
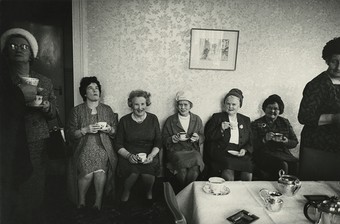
[[210, 144, 253, 173]]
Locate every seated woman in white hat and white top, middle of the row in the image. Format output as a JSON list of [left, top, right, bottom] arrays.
[[162, 91, 204, 187]]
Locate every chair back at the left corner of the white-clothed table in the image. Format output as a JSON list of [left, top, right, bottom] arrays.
[[163, 182, 187, 224]]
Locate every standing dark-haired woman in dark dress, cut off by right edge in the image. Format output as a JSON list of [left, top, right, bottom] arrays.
[[298, 37, 340, 180]]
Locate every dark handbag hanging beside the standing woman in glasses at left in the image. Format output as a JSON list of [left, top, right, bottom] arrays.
[[47, 110, 73, 160]]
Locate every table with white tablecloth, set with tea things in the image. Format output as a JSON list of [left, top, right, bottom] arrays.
[[176, 181, 340, 224]]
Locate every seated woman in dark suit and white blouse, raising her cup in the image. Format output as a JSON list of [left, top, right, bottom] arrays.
[[205, 89, 253, 181]]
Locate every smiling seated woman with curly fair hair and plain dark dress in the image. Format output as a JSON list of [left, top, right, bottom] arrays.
[[115, 90, 162, 202]]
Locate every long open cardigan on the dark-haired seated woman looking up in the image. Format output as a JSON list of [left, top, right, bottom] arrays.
[[66, 103, 118, 204]]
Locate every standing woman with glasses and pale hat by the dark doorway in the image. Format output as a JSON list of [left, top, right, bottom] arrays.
[[1, 28, 57, 223]]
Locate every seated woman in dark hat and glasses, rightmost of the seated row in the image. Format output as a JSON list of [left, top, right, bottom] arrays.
[[251, 94, 299, 180]]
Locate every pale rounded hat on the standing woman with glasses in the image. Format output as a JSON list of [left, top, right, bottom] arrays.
[[1, 28, 39, 58]]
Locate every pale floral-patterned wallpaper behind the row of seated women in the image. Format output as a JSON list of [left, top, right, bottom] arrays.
[[81, 0, 340, 156]]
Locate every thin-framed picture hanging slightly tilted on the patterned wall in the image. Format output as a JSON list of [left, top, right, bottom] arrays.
[[189, 28, 239, 71]]
